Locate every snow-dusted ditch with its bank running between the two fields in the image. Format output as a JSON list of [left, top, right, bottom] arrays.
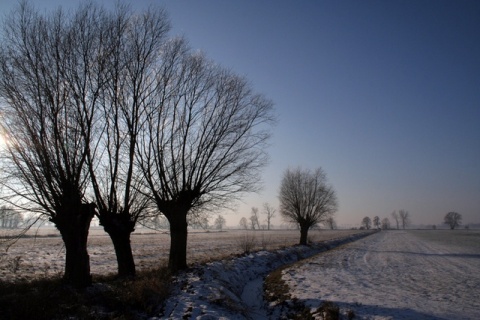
[[157, 233, 370, 320]]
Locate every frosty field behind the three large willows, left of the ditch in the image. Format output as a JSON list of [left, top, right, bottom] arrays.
[[0, 228, 364, 281]]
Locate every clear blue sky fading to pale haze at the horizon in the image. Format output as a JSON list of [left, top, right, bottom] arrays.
[[0, 0, 480, 227]]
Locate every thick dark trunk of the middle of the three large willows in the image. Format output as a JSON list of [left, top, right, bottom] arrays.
[[100, 213, 136, 278]]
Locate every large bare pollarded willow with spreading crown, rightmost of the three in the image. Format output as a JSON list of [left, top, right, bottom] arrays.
[[138, 39, 274, 271]]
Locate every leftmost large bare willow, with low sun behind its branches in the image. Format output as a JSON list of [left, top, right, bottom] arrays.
[[0, 2, 101, 287]]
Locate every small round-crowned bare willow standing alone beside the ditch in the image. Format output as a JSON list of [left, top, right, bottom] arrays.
[[279, 168, 338, 245]]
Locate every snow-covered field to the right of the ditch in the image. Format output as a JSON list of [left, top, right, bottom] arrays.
[[282, 231, 480, 320]]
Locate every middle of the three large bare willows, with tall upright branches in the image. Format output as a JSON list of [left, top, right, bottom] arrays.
[[79, 6, 169, 277]]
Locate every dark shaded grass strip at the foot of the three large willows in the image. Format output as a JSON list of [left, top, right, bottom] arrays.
[[0, 268, 171, 320]]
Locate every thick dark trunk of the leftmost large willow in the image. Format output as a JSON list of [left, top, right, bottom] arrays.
[[52, 205, 94, 289]]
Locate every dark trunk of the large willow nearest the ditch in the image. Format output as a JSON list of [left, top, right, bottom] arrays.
[[168, 212, 188, 273]]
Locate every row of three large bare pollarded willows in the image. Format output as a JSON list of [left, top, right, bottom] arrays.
[[0, 2, 274, 287]]
